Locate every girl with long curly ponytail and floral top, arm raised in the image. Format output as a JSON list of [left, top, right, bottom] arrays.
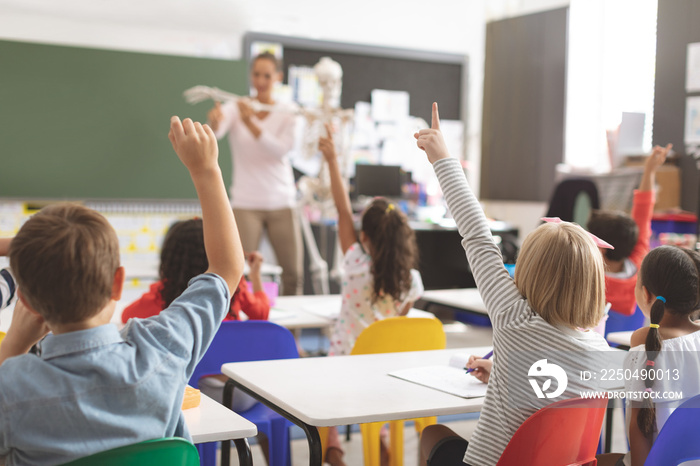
[[318, 125, 423, 465]]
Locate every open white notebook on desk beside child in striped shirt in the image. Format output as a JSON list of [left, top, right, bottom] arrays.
[[389, 354, 488, 398]]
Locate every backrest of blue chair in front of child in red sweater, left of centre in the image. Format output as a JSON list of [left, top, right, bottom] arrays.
[[190, 320, 299, 388]]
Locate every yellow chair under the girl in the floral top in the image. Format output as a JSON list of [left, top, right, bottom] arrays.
[[350, 317, 445, 466]]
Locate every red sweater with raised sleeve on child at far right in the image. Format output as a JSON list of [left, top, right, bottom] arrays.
[[605, 190, 654, 316]]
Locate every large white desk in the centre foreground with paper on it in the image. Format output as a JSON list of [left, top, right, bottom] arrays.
[[221, 347, 491, 466]]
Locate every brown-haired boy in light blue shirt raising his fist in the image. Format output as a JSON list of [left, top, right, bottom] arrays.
[[0, 117, 243, 465]]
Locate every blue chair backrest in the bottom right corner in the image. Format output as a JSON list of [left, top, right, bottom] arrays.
[[644, 395, 700, 466]]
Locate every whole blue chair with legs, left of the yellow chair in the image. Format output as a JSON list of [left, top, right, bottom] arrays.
[[190, 320, 299, 466]]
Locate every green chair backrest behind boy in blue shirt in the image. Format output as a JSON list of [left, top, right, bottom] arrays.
[[64, 438, 199, 466]]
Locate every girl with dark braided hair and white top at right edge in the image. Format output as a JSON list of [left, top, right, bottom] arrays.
[[598, 246, 700, 466]]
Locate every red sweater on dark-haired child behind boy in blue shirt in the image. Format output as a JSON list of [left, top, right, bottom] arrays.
[[122, 278, 270, 323]]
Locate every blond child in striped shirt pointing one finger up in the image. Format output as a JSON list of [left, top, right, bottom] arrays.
[[415, 103, 608, 466]]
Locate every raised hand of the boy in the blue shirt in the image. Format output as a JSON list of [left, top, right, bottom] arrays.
[[168, 116, 219, 175]]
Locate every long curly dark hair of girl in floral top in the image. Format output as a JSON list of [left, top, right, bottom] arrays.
[[362, 198, 418, 302]]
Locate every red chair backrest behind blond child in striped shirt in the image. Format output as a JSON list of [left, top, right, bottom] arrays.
[[497, 398, 608, 466]]
